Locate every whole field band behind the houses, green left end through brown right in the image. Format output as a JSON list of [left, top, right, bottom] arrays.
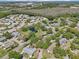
[[0, 7, 79, 18]]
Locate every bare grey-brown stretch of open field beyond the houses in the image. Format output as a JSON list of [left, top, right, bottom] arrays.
[[11, 7, 79, 16]]
